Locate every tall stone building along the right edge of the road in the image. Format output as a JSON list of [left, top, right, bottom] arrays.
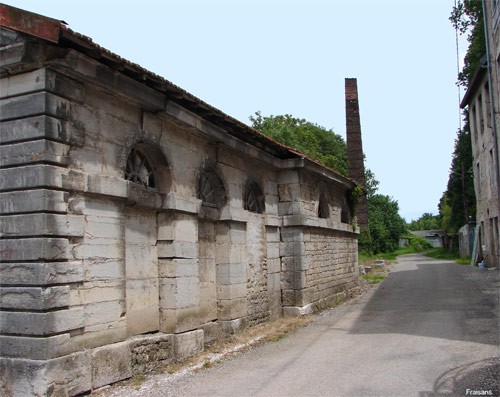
[[461, 0, 500, 268]]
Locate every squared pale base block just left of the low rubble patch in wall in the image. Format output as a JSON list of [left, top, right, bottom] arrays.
[[91, 342, 132, 389]]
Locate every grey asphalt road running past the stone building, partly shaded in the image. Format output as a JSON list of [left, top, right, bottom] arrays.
[[103, 255, 500, 397]]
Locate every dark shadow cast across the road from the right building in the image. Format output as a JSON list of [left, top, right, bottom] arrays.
[[349, 255, 499, 346]]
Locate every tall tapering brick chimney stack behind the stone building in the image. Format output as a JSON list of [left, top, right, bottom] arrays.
[[345, 78, 368, 231]]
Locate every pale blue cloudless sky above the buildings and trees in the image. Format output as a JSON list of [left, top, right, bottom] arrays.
[[3, 0, 463, 221]]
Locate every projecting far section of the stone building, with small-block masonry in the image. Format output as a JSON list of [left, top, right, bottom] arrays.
[[279, 171, 358, 315]]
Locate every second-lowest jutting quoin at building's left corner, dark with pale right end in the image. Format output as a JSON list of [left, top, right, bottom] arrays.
[[0, 286, 70, 310]]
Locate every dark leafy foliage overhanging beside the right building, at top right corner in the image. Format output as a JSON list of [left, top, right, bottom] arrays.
[[450, 0, 486, 86]]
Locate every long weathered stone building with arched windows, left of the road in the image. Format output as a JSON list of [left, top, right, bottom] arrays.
[[0, 5, 358, 396]]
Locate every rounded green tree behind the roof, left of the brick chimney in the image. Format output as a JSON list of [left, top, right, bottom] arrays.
[[250, 112, 347, 175]]
